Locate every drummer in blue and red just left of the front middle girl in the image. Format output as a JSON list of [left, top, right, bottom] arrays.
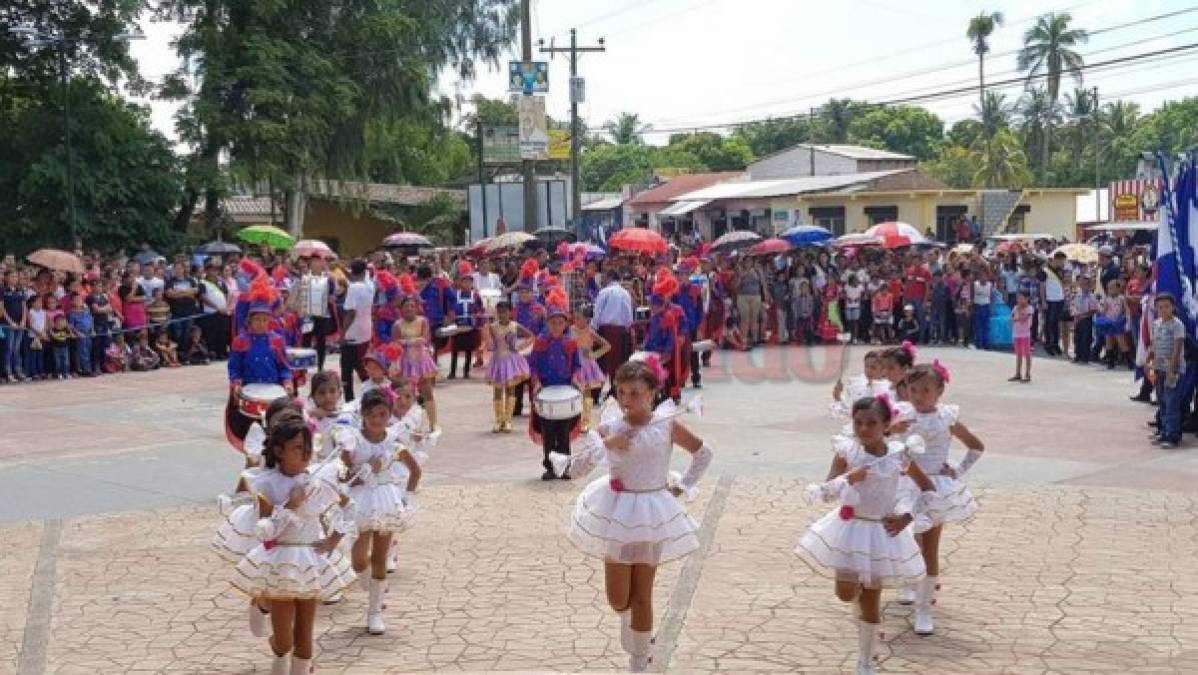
[[528, 288, 582, 481]]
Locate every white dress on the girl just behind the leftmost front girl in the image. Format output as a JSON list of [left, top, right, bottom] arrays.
[[347, 427, 413, 534]]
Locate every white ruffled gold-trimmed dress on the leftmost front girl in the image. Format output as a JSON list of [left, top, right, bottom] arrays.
[[231, 469, 355, 601]]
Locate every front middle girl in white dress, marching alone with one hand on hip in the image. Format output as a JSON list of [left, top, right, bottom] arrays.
[[552, 357, 713, 671]]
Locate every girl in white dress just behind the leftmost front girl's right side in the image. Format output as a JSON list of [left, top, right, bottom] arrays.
[[341, 390, 420, 635]]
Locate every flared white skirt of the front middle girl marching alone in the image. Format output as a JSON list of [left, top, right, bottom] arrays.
[[569, 476, 698, 566]]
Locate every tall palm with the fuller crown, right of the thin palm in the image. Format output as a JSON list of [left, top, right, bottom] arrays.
[[1016, 12, 1090, 177]]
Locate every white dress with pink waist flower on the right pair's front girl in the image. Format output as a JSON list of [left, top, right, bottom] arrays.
[[794, 436, 925, 587]]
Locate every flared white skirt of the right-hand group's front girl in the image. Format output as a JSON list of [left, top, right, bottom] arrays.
[[794, 507, 925, 587]]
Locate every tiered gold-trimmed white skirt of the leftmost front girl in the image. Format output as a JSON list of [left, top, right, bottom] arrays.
[[232, 543, 356, 601]]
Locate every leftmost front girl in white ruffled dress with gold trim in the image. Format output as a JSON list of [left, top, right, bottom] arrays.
[[232, 412, 353, 675]]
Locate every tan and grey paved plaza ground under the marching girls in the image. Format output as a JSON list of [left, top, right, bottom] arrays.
[[0, 349, 1198, 674]]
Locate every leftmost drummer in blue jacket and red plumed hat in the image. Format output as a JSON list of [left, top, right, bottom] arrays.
[[225, 275, 295, 451]]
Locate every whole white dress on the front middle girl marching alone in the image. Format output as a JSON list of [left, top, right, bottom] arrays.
[[568, 400, 698, 565]]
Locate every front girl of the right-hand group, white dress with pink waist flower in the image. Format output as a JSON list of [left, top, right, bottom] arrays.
[[795, 397, 932, 675]]
